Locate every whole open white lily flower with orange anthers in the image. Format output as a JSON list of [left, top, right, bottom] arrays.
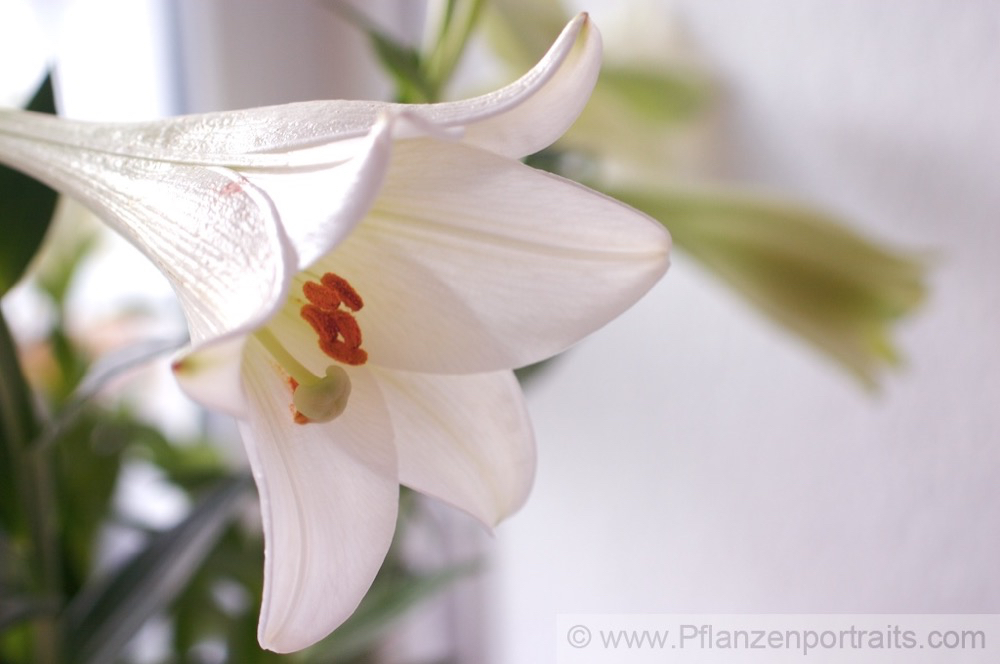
[[0, 15, 670, 652]]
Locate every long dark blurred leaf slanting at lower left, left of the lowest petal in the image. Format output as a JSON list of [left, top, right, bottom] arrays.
[[64, 476, 251, 664]]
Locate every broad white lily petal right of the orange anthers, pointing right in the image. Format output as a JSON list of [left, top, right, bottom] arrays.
[[313, 139, 670, 373]]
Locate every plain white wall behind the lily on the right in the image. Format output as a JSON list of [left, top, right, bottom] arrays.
[[493, 0, 1000, 663]]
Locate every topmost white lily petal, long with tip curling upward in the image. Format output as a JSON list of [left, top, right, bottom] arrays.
[[0, 14, 601, 163]]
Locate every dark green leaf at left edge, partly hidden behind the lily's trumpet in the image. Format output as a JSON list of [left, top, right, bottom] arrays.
[[0, 77, 57, 295]]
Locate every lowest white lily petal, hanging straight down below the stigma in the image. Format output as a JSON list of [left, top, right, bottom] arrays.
[[240, 340, 399, 652]]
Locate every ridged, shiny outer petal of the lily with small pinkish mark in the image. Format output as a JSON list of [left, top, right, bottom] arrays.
[[0, 131, 294, 345]]
